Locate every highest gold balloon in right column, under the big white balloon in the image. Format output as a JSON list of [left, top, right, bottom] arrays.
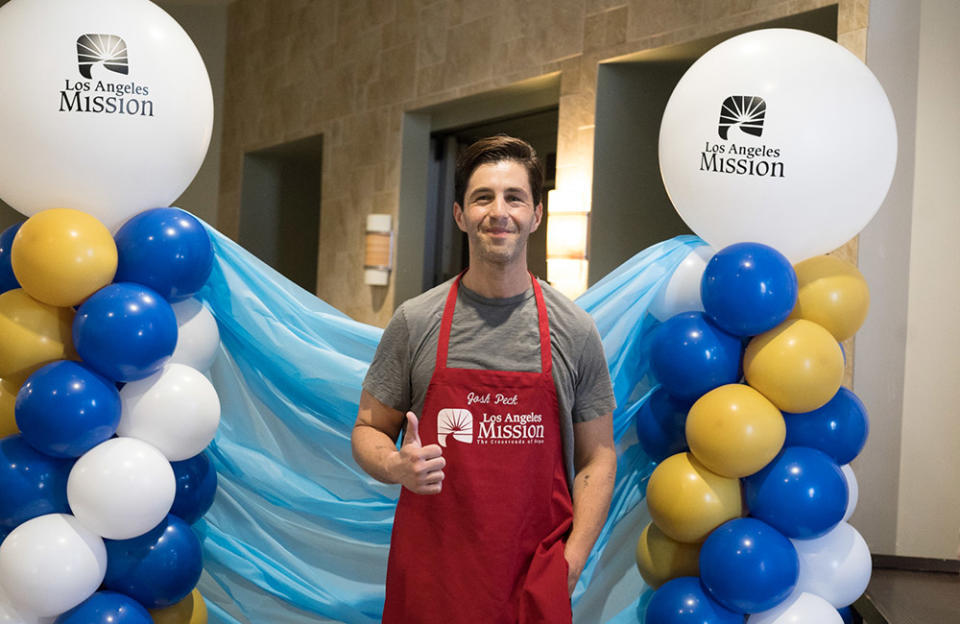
[[790, 256, 870, 342]]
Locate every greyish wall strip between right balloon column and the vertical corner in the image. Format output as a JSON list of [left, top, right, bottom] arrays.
[[850, 0, 920, 554]]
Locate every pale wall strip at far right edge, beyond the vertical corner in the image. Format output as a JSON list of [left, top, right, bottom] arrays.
[[896, 0, 960, 557]]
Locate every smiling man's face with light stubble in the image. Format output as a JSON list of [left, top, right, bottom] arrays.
[[453, 160, 543, 264]]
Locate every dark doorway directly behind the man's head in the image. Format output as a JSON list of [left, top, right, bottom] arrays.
[[423, 107, 558, 290]]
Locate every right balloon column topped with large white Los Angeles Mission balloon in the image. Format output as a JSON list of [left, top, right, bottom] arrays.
[[637, 30, 896, 624]]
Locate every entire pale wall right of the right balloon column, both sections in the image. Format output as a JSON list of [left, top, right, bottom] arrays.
[[851, 0, 960, 558]]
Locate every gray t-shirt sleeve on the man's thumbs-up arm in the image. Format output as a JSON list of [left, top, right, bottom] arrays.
[[363, 306, 411, 412]]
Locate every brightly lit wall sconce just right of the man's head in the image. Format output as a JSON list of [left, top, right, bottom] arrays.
[[547, 189, 590, 299]]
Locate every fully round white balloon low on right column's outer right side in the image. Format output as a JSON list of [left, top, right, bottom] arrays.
[[790, 522, 873, 609]]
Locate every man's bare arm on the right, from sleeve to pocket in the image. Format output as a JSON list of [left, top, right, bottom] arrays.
[[563, 414, 617, 594]]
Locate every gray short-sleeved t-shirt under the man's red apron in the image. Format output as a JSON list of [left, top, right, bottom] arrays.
[[363, 280, 615, 484]]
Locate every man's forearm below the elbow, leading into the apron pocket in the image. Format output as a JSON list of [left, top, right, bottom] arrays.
[[565, 448, 617, 580]]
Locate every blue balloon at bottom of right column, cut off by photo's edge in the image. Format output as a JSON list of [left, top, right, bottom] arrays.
[[644, 576, 743, 624]]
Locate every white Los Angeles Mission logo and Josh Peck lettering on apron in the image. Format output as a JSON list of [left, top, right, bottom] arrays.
[[437, 392, 544, 447]]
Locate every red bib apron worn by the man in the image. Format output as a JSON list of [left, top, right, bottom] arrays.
[[383, 274, 573, 624]]
